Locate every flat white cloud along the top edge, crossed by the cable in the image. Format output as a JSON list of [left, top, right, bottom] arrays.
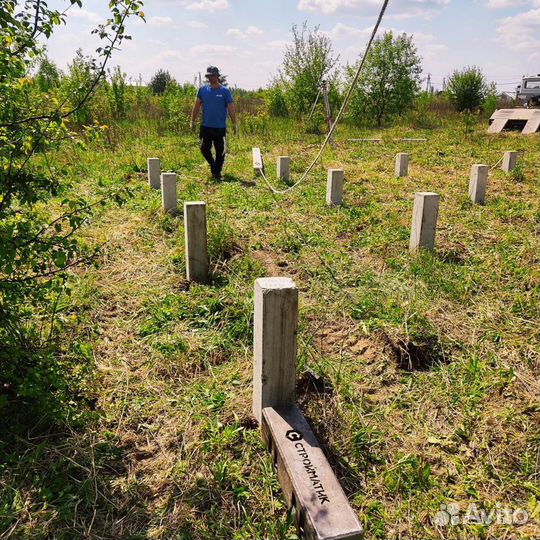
[[297, 0, 450, 19]]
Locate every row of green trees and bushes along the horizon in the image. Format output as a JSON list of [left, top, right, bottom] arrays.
[[34, 23, 497, 132]]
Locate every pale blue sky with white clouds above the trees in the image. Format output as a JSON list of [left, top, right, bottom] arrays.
[[48, 0, 540, 91]]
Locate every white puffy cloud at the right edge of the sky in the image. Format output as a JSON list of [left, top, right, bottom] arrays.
[[495, 8, 540, 52]]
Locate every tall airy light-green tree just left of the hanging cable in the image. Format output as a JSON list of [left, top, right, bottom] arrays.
[[274, 22, 340, 116]]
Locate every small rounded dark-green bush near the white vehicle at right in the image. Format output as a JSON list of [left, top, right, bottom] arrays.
[[446, 66, 489, 112]]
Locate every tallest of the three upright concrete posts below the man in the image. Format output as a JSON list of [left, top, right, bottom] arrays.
[[184, 201, 209, 283]]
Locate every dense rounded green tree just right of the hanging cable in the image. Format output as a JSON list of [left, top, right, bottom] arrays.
[[347, 32, 422, 126]]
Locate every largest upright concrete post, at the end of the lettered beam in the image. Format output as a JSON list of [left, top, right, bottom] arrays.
[[253, 277, 298, 424]]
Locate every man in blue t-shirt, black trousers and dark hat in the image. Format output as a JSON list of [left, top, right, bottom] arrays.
[[190, 66, 236, 180]]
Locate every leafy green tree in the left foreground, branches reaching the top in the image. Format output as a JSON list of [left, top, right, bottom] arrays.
[[0, 0, 144, 418]]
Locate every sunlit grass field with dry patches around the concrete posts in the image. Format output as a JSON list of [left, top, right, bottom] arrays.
[[0, 116, 540, 540]]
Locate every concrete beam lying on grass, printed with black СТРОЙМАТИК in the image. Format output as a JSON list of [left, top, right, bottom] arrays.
[[262, 405, 363, 540]]
